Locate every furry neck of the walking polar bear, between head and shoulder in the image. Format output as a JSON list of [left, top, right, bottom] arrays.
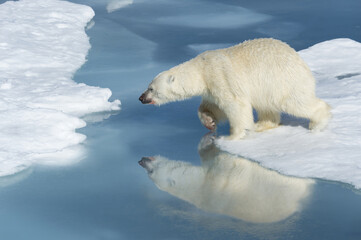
[[169, 59, 206, 99]]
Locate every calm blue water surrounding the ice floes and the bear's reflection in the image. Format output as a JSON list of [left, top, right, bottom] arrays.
[[0, 0, 361, 240]]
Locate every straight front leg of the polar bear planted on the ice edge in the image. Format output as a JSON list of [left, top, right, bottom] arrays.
[[218, 100, 254, 140]]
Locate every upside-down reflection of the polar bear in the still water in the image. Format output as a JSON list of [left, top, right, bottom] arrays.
[[139, 137, 314, 223]]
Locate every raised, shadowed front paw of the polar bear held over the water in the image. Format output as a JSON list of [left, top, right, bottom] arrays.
[[198, 99, 225, 131]]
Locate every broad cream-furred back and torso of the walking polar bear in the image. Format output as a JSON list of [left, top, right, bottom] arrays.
[[194, 38, 315, 110]]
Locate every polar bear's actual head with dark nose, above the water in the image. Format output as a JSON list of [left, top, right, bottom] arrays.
[[139, 71, 187, 105]]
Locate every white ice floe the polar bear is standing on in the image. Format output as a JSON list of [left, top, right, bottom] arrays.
[[218, 39, 361, 189]]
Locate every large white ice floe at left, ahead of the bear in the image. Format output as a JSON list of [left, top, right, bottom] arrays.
[[0, 0, 120, 176]]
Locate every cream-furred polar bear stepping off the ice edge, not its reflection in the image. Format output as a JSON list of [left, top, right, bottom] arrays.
[[139, 38, 331, 140]]
